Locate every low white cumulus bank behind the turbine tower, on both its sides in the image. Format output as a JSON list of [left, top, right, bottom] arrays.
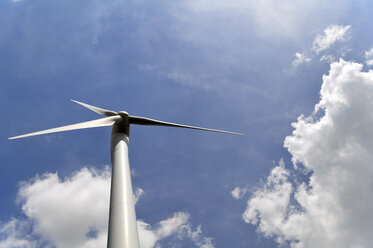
[[0, 167, 213, 248]]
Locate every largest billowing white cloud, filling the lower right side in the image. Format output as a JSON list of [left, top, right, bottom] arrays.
[[243, 60, 373, 248]]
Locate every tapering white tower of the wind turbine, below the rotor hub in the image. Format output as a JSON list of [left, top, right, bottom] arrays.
[[107, 133, 140, 248]]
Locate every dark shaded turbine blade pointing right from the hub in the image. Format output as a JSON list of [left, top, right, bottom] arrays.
[[129, 116, 245, 135]]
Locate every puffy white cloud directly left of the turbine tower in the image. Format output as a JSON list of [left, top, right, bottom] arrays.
[[18, 168, 110, 247]]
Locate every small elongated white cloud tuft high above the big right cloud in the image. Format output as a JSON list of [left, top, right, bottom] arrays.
[[312, 25, 351, 54]]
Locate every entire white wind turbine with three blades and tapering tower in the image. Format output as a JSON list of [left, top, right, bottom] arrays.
[[9, 100, 244, 248]]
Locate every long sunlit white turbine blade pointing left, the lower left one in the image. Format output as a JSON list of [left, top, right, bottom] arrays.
[[8, 115, 122, 139]]
